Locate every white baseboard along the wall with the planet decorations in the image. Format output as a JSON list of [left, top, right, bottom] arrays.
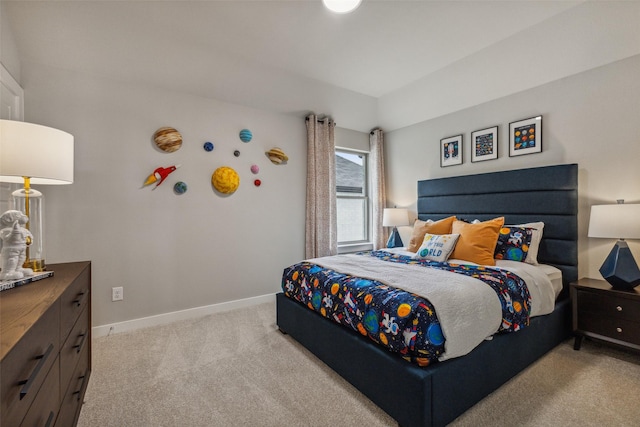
[[91, 294, 276, 338]]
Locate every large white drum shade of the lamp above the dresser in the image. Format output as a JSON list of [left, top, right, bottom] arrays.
[[0, 120, 73, 184]]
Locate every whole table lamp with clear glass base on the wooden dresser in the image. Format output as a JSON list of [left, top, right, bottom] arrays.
[[0, 120, 73, 272]]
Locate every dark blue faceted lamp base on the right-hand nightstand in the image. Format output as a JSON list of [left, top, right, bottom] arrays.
[[600, 240, 640, 291]]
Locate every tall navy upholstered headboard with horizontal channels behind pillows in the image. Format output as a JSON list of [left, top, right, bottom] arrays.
[[418, 164, 578, 294]]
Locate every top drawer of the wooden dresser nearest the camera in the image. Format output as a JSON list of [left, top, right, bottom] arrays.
[[0, 303, 60, 426]]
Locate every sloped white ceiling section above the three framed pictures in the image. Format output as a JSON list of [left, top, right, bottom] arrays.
[[378, 1, 640, 129]]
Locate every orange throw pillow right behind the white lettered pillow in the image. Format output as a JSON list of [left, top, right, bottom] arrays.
[[450, 217, 504, 265]]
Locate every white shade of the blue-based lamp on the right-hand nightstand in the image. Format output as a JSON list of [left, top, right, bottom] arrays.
[[589, 203, 640, 239]]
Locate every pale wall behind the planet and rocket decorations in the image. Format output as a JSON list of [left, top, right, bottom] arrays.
[[22, 62, 306, 325]]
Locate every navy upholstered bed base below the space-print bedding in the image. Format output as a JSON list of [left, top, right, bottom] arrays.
[[276, 293, 571, 427]]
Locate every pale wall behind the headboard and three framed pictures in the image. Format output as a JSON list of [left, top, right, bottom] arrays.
[[385, 55, 640, 278]]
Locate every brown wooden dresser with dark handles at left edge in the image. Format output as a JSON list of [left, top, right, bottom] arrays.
[[0, 261, 91, 427]]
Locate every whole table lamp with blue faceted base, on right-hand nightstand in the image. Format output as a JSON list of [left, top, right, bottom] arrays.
[[588, 200, 640, 290]]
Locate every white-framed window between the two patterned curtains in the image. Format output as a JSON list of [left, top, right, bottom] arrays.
[[336, 149, 371, 246]]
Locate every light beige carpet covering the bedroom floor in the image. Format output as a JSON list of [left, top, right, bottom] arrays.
[[78, 303, 640, 427]]
